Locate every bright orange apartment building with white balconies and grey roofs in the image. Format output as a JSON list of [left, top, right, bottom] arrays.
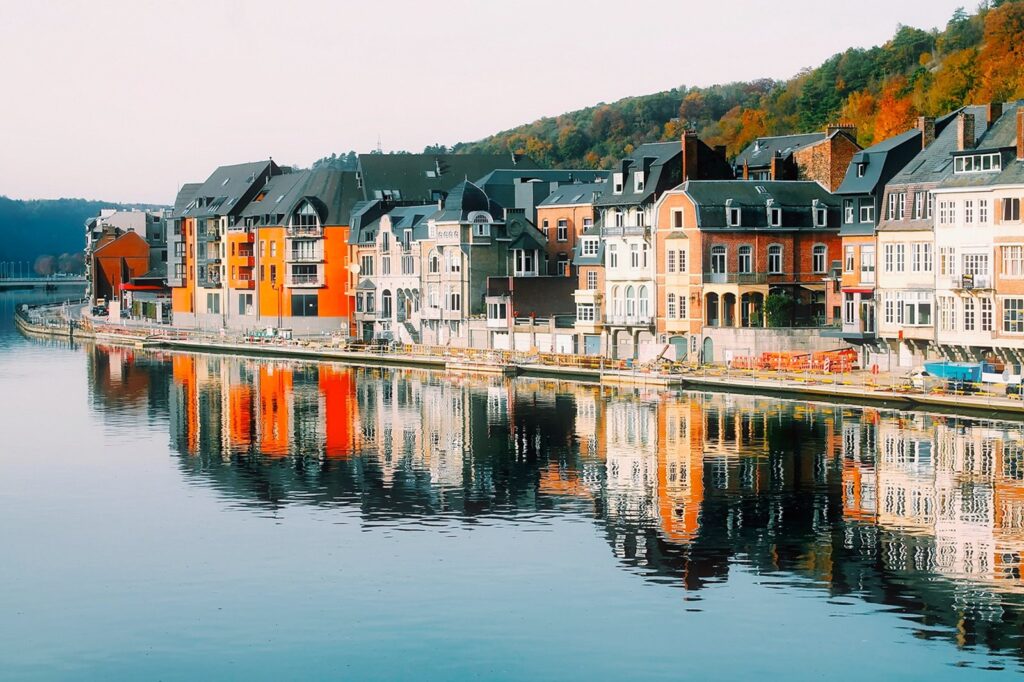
[[170, 161, 360, 334]]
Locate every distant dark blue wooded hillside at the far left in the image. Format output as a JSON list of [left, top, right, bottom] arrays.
[[0, 196, 164, 263]]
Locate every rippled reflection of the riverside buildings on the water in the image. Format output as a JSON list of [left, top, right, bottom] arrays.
[[0, 290, 1024, 677]]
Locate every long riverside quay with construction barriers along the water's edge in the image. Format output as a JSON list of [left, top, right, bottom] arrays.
[[15, 304, 1024, 418]]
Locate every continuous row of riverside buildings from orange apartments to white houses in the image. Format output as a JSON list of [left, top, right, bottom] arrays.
[[121, 102, 1024, 368]]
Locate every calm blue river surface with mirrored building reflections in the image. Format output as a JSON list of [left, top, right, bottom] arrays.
[[0, 288, 1024, 680]]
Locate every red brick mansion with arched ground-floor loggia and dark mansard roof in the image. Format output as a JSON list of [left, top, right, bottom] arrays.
[[655, 180, 840, 361]]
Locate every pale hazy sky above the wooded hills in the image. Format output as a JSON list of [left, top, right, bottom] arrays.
[[0, 0, 976, 204]]
